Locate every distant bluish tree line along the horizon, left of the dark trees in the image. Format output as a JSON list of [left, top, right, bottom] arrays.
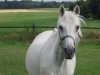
[[0, 0, 72, 9]]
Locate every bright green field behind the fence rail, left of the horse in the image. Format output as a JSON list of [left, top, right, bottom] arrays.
[[0, 12, 58, 26]]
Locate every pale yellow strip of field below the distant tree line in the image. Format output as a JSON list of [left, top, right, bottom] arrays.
[[0, 9, 57, 13]]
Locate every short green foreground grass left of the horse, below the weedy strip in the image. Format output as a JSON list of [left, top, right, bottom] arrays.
[[0, 41, 29, 75]]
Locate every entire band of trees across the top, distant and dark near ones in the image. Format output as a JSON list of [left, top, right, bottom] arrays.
[[0, 0, 100, 19]]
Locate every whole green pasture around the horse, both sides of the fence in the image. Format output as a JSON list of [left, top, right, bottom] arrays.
[[0, 9, 100, 75]]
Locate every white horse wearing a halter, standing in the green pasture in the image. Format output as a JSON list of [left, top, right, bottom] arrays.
[[26, 5, 83, 75]]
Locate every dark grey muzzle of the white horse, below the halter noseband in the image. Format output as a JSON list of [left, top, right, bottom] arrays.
[[64, 48, 75, 59]]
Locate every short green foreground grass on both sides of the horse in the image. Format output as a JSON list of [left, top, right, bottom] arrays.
[[0, 41, 100, 75]]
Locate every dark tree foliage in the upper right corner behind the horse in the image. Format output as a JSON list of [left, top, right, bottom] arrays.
[[76, 0, 100, 19]]
